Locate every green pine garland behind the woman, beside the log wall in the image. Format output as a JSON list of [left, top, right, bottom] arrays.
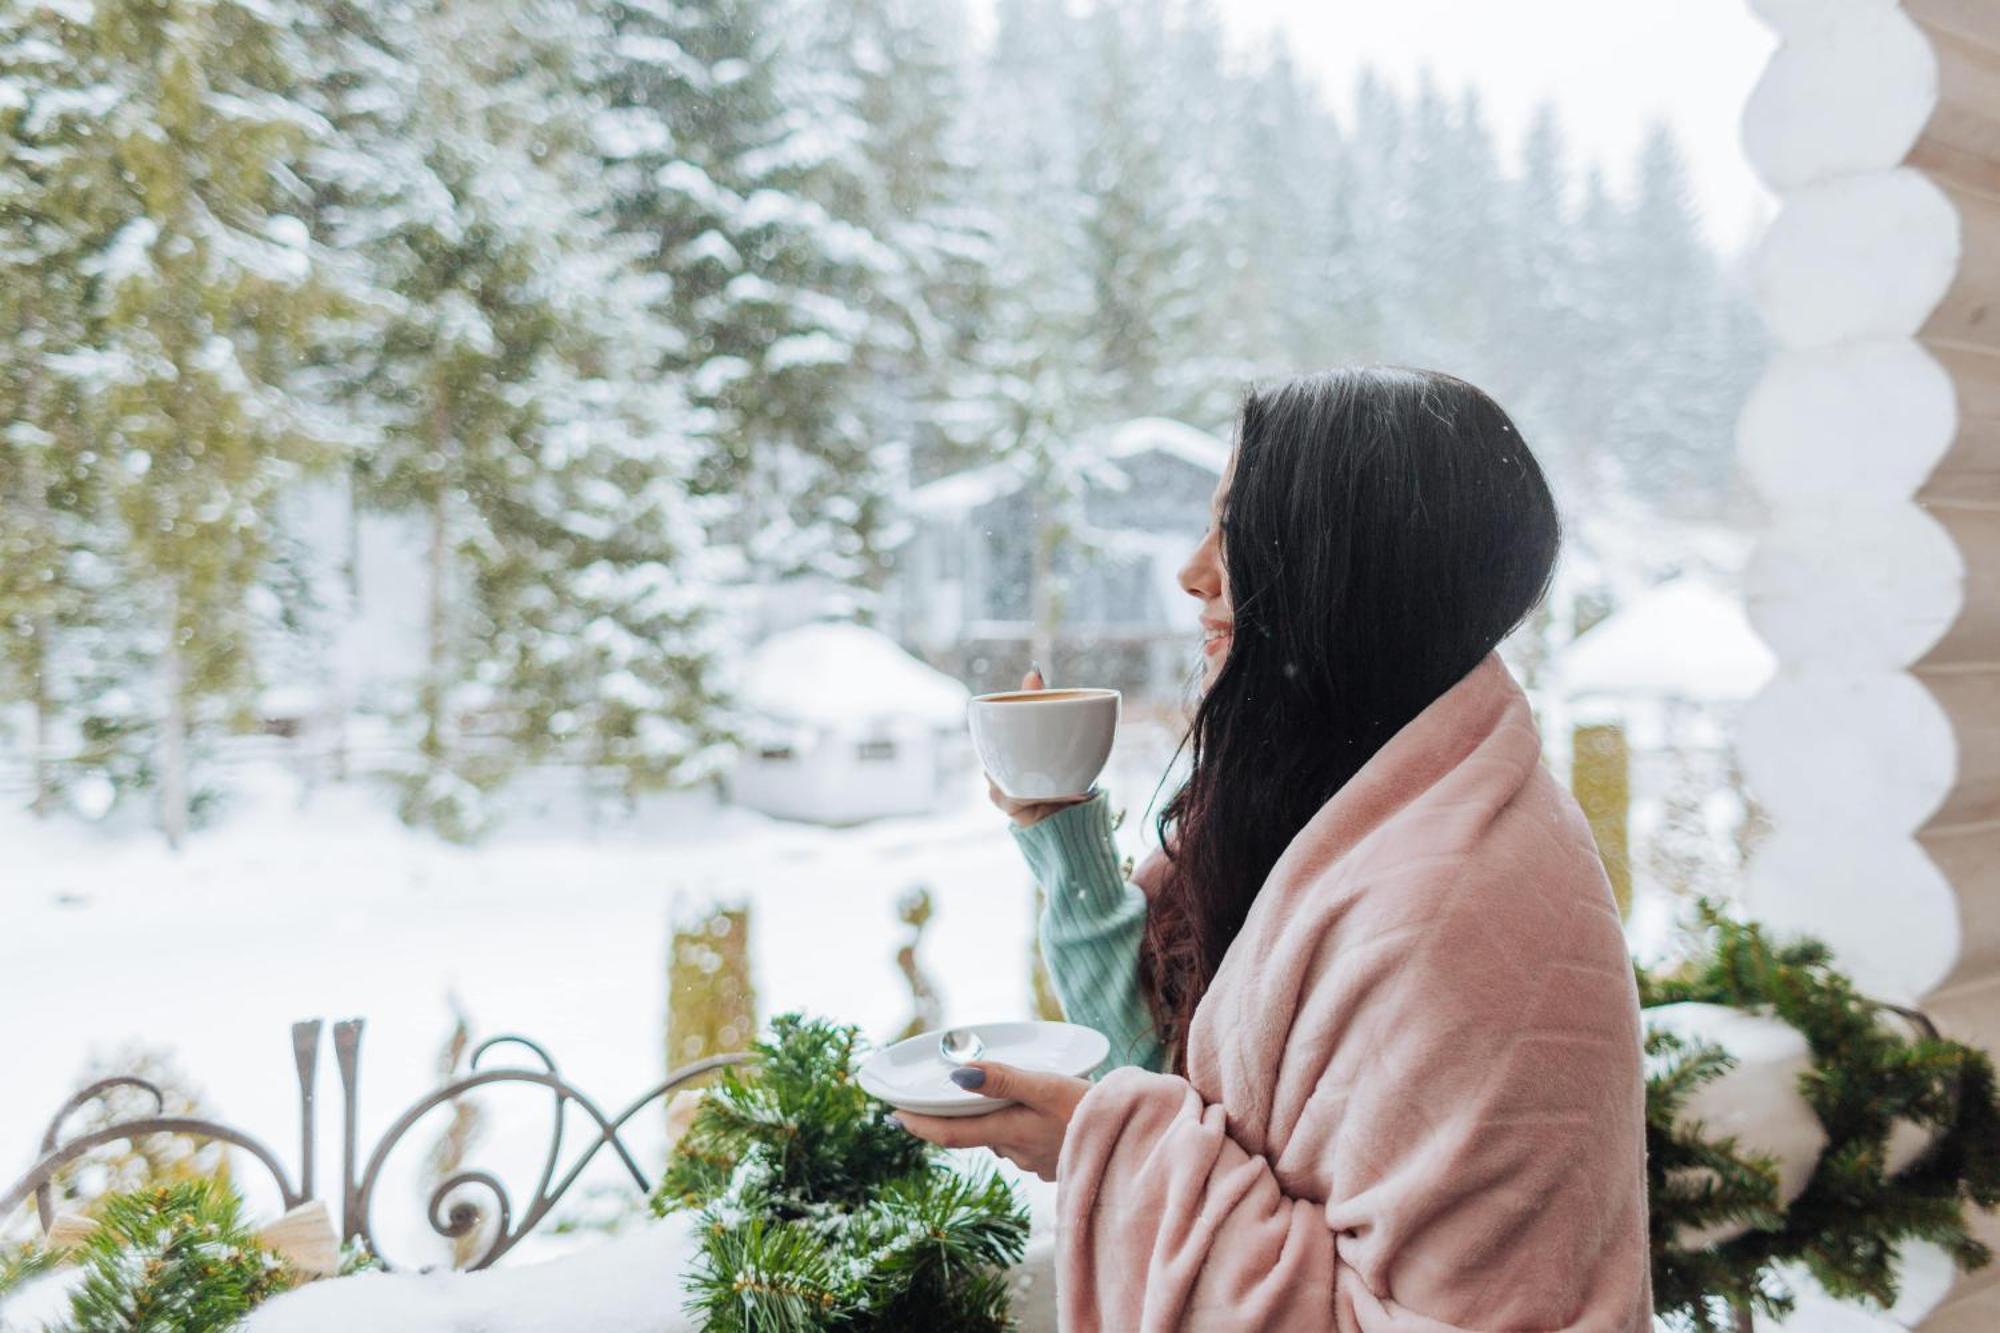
[[1638, 899, 2000, 1333]]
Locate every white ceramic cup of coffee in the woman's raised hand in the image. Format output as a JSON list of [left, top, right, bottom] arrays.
[[966, 689, 1118, 801]]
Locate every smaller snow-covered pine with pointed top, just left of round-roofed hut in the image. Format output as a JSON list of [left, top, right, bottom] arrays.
[[488, 264, 728, 797]]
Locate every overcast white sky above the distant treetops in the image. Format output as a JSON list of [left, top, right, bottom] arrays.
[[976, 0, 1776, 248]]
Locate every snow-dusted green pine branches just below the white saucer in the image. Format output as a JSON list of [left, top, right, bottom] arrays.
[[652, 1015, 1028, 1333]]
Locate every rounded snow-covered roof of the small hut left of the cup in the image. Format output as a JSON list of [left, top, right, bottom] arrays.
[[740, 620, 972, 725]]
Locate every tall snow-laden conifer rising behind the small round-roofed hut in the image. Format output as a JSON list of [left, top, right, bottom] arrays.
[[594, 0, 892, 578]]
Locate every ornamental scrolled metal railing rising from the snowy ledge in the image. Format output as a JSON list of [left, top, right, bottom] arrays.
[[0, 1019, 752, 1271]]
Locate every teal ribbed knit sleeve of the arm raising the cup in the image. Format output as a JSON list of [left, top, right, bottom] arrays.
[[1012, 791, 1166, 1071]]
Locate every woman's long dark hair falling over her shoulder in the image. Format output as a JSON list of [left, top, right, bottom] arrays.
[[1142, 366, 1562, 1069]]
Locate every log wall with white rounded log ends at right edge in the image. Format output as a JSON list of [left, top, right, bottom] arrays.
[[1738, 0, 2000, 1312]]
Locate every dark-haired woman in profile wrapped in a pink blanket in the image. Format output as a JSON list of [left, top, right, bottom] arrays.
[[902, 368, 1650, 1333]]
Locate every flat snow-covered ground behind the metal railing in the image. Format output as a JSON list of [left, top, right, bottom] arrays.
[[0, 737, 1160, 1265]]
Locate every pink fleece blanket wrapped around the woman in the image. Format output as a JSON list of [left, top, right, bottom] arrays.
[[1056, 654, 1652, 1333]]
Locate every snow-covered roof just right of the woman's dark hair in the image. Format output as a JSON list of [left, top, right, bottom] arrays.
[[1558, 578, 1778, 703]]
